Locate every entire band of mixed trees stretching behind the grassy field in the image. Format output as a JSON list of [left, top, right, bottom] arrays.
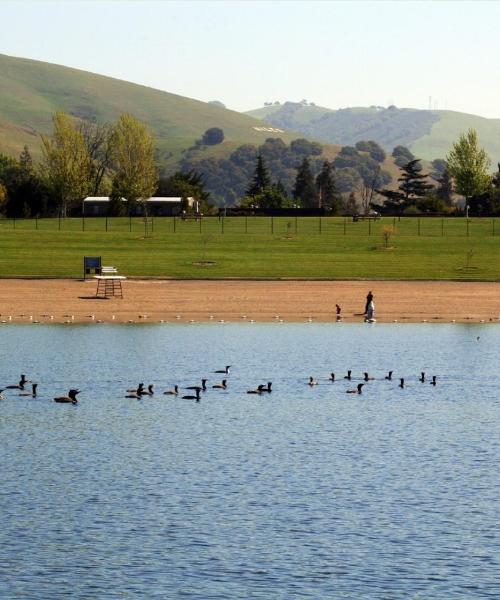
[[0, 112, 500, 217]]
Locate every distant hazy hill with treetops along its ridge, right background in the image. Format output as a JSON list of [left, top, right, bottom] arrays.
[[247, 102, 500, 163]]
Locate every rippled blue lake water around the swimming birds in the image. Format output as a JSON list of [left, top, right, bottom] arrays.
[[0, 323, 500, 600]]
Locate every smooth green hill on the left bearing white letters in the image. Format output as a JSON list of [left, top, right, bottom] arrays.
[[0, 54, 298, 158]]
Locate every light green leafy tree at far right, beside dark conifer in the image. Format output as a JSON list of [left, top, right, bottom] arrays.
[[446, 129, 491, 203]]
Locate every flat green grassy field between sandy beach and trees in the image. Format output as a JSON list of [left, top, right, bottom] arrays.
[[0, 217, 500, 281]]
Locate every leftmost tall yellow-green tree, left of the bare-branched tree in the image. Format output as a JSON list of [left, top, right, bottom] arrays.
[[41, 111, 90, 216]]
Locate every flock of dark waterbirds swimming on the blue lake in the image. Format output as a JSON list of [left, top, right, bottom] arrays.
[[0, 365, 437, 404]]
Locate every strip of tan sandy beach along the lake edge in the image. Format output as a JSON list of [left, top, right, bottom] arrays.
[[0, 279, 500, 323]]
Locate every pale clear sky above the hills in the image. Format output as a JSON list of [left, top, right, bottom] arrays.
[[0, 0, 500, 118]]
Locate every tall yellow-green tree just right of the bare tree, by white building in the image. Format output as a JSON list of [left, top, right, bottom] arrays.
[[111, 113, 158, 217]]
